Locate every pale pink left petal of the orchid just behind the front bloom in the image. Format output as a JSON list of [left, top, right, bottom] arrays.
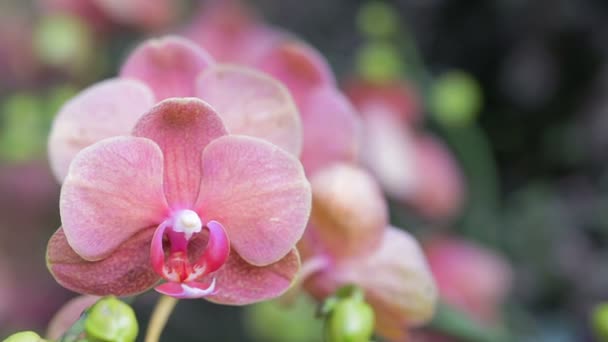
[[48, 79, 155, 182]]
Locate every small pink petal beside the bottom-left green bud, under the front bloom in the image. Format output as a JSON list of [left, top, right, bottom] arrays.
[[46, 295, 101, 340]]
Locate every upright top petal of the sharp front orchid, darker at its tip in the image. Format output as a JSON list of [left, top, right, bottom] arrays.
[[133, 98, 227, 207]]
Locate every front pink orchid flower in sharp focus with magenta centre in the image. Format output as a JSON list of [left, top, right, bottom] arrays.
[[47, 98, 311, 304]]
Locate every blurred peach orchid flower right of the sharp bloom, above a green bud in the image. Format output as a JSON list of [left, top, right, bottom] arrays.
[[298, 164, 436, 340]]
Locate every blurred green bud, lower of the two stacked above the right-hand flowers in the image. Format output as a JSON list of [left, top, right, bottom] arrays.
[[357, 42, 404, 83]]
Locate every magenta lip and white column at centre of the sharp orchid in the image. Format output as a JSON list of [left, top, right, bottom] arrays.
[[150, 209, 230, 298]]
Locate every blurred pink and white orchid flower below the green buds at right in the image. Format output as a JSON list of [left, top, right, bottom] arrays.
[[346, 81, 465, 219]]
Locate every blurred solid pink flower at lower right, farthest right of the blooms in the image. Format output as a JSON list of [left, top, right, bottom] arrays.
[[424, 237, 513, 323]]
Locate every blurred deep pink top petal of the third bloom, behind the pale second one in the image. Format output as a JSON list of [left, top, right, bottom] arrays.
[[257, 39, 336, 97]]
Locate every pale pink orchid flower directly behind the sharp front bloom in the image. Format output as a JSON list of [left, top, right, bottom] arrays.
[[49, 36, 302, 181]]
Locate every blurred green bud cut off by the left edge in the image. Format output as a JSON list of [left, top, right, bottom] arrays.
[[0, 93, 47, 161]]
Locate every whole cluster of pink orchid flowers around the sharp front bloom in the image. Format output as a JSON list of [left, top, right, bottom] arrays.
[[2, 1, 516, 341]]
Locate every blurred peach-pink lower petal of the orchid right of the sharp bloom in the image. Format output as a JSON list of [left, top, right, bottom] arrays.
[[305, 227, 437, 339]]
